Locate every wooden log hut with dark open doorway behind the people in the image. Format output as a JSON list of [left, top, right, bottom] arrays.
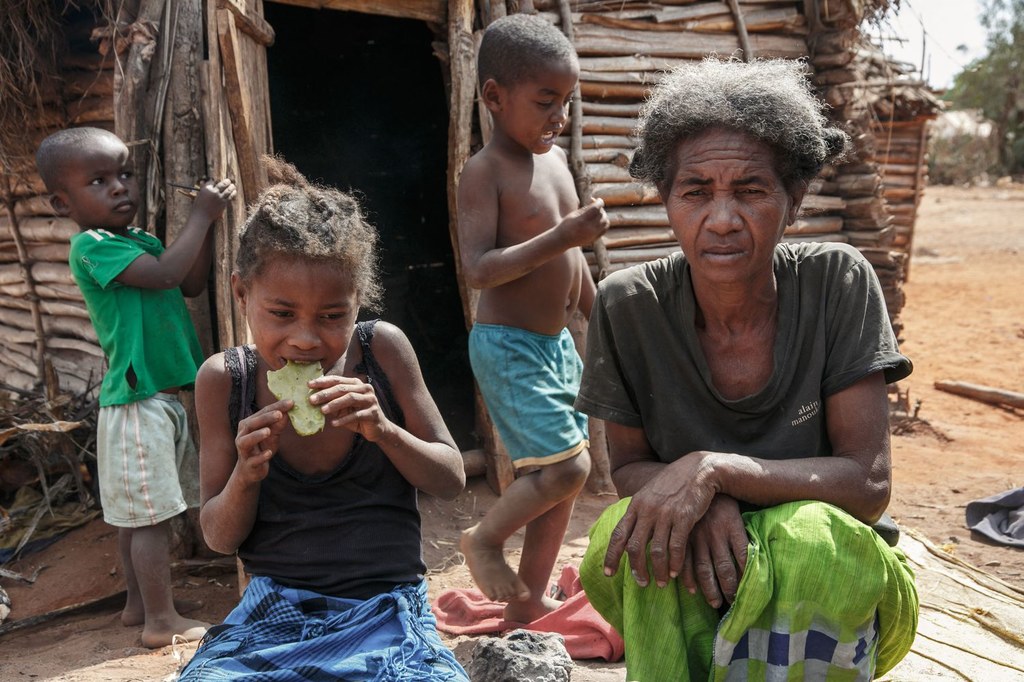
[[0, 0, 937, 491]]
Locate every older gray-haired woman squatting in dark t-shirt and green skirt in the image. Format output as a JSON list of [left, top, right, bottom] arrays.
[[577, 59, 918, 682]]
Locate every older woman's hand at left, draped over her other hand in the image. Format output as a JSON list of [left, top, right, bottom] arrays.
[[604, 452, 718, 587]]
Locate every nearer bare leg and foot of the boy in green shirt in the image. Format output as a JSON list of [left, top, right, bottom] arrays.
[[126, 521, 210, 648]]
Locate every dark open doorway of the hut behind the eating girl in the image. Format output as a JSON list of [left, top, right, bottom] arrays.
[[263, 2, 476, 450]]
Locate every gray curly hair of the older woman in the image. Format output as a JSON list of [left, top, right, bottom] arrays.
[[630, 56, 850, 190]]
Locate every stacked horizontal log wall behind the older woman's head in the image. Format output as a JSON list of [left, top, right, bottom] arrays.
[[516, 0, 929, 334]]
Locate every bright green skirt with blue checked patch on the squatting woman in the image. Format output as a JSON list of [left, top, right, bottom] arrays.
[[580, 498, 918, 682]]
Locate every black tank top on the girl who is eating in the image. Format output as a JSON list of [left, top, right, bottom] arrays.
[[224, 321, 426, 599]]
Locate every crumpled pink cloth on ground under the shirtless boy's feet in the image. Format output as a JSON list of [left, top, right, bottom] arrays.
[[433, 566, 625, 662]]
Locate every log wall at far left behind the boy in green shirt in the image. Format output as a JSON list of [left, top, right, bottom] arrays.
[[0, 13, 114, 394]]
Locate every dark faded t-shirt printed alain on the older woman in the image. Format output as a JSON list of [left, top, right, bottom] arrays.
[[575, 243, 911, 462]]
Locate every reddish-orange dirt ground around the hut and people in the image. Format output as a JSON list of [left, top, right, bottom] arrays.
[[0, 184, 1024, 682]]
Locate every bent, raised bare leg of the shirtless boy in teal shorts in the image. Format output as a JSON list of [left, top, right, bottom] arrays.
[[461, 451, 590, 601]]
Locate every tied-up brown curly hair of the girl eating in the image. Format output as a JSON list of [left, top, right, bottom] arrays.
[[234, 157, 383, 311]]
